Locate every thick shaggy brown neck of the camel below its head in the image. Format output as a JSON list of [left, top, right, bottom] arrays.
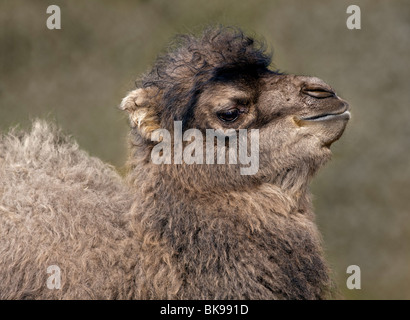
[[133, 174, 329, 299]]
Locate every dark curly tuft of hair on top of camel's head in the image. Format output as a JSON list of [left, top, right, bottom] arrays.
[[140, 27, 272, 124]]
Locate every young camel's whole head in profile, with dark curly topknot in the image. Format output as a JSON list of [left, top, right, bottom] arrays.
[[121, 28, 350, 190]]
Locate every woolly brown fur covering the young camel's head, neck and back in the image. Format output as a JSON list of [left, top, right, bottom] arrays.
[[0, 28, 348, 299]]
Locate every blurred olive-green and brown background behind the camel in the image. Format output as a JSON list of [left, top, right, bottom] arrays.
[[0, 0, 410, 299]]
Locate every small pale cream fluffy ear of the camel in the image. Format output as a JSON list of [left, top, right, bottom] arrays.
[[120, 88, 160, 140]]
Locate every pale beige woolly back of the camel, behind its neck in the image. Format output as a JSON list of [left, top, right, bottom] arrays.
[[0, 121, 135, 299]]
